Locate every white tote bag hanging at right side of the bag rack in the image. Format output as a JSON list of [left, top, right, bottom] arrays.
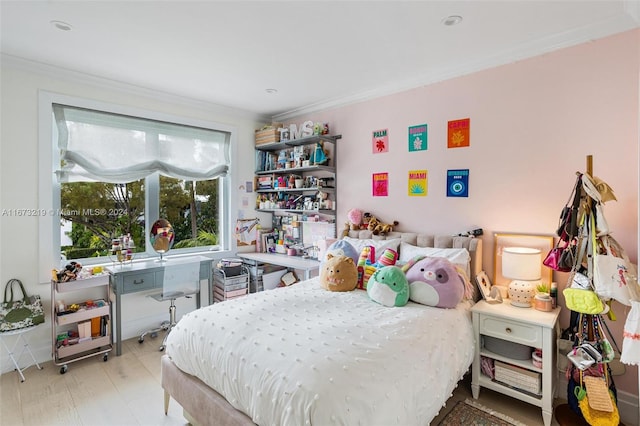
[[593, 235, 637, 306]]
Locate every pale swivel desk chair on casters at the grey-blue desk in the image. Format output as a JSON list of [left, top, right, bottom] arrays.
[[138, 259, 200, 351]]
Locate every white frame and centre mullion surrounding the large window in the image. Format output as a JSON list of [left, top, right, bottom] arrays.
[[38, 91, 237, 282]]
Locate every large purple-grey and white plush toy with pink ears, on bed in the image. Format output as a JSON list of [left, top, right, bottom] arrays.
[[402, 256, 473, 308]]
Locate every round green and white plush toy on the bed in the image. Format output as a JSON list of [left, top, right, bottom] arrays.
[[367, 266, 409, 307]]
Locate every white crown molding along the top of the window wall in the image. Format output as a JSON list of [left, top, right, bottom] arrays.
[[0, 53, 271, 122]]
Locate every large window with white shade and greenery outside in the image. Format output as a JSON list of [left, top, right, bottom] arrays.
[[49, 102, 232, 263]]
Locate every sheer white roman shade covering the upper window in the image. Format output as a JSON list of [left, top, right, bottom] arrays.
[[53, 104, 230, 183]]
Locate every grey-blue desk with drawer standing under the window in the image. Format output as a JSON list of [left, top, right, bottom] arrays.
[[105, 256, 213, 356]]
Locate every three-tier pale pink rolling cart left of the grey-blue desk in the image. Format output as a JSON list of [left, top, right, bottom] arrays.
[[51, 274, 113, 374]]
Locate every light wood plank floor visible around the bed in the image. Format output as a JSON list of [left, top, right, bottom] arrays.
[[0, 338, 557, 426]]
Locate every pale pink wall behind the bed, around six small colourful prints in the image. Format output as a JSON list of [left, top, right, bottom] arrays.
[[288, 30, 640, 395]]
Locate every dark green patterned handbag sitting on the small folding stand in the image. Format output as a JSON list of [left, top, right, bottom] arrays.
[[0, 278, 44, 332]]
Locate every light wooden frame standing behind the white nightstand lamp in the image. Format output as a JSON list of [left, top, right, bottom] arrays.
[[493, 233, 554, 287]]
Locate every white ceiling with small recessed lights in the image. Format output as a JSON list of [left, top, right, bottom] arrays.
[[0, 0, 640, 118]]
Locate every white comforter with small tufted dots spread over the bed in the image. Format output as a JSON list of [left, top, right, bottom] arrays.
[[166, 278, 474, 426]]
